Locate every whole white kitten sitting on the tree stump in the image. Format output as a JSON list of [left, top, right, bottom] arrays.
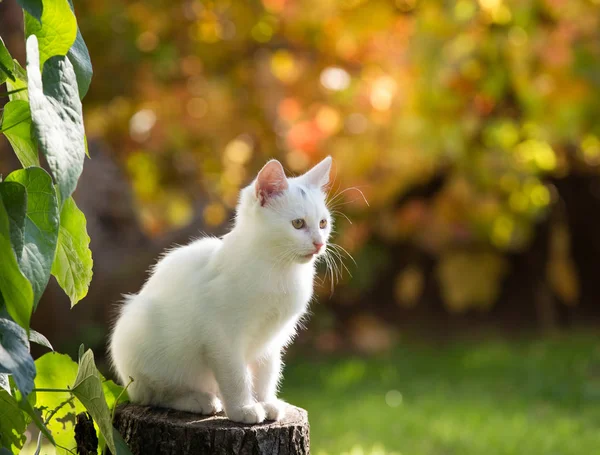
[[110, 157, 331, 423]]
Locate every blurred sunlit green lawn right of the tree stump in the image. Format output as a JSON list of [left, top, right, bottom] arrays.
[[282, 335, 600, 455]]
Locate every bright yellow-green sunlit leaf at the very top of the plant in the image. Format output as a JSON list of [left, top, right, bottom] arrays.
[[25, 0, 77, 68]]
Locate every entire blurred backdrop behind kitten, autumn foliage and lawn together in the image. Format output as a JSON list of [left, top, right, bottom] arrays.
[[0, 0, 600, 455]]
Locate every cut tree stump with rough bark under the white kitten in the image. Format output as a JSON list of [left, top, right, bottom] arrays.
[[114, 404, 310, 455]]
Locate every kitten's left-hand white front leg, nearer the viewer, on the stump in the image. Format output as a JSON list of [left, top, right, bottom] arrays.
[[214, 355, 266, 423]]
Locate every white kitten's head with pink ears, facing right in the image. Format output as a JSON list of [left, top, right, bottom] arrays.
[[238, 157, 332, 263]]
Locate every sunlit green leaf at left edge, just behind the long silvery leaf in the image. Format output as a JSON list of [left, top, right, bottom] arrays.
[[2, 100, 40, 167]]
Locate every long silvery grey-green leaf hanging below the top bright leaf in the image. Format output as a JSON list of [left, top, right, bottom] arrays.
[[27, 36, 85, 201]]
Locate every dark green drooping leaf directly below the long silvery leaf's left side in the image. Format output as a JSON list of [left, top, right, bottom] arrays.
[[5, 167, 59, 308]]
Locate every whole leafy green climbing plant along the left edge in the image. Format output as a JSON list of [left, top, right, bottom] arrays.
[[0, 0, 130, 454]]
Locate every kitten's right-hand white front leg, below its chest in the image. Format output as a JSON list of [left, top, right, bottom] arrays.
[[252, 349, 287, 420]]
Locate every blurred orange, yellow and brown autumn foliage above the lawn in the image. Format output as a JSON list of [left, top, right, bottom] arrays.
[[3, 0, 600, 350]]
